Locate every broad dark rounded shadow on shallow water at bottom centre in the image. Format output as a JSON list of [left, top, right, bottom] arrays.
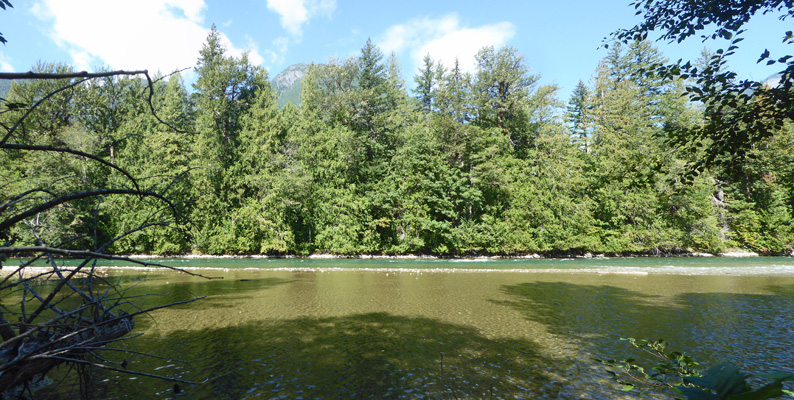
[[76, 313, 561, 399]]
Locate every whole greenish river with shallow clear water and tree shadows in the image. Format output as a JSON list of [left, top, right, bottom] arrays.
[[37, 257, 794, 399]]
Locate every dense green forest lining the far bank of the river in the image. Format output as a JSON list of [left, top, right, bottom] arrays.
[[0, 28, 794, 256]]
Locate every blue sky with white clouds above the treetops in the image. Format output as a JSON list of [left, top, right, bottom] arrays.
[[0, 0, 794, 101]]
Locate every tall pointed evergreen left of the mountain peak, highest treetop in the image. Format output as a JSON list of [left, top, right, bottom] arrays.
[[193, 25, 267, 253]]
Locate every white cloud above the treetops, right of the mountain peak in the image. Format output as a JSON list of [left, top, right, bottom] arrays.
[[378, 14, 515, 72]]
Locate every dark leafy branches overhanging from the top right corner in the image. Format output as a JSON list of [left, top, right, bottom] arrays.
[[612, 0, 794, 177]]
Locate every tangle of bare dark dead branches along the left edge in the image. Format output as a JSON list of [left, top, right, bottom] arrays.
[[0, 65, 207, 393]]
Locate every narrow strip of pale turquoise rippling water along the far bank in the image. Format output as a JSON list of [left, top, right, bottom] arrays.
[[6, 256, 794, 277]]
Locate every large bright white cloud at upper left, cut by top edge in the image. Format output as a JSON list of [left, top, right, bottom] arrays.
[[31, 0, 262, 73]]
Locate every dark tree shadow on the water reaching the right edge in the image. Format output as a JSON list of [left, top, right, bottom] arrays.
[[498, 282, 794, 396]]
